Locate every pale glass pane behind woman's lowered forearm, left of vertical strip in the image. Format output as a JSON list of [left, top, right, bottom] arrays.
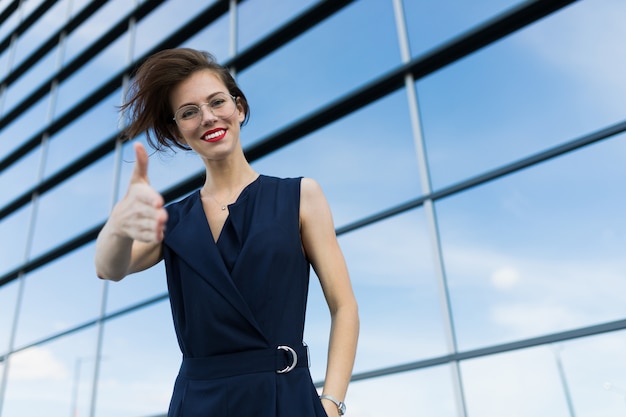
[[305, 211, 446, 380]]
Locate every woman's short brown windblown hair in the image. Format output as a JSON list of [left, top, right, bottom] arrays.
[[120, 48, 250, 150]]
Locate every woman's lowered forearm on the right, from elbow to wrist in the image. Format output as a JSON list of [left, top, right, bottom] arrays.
[[323, 302, 359, 416]]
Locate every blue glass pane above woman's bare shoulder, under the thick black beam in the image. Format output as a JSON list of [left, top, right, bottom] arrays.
[[249, 91, 420, 226]]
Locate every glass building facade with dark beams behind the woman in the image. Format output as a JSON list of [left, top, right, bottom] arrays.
[[0, 0, 626, 417]]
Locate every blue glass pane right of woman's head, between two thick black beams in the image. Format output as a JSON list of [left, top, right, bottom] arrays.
[[238, 0, 400, 144]]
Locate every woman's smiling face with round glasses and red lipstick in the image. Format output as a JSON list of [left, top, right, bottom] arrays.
[[170, 70, 245, 160]]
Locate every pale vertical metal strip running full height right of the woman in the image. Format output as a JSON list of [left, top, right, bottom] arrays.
[[393, 0, 467, 417]]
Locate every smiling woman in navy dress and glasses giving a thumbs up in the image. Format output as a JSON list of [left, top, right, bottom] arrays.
[[95, 49, 359, 417]]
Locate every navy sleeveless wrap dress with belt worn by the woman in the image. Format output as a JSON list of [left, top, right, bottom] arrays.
[[163, 175, 326, 417]]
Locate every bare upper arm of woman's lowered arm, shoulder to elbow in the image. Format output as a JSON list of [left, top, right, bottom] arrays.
[[300, 178, 354, 310]]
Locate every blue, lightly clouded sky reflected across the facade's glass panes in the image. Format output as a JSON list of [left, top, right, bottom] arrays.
[[0, 0, 626, 417]]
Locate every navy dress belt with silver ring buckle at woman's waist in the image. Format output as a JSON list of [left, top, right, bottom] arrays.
[[179, 344, 309, 379]]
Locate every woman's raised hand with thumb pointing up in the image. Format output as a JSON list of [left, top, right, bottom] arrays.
[[111, 143, 167, 242]]
